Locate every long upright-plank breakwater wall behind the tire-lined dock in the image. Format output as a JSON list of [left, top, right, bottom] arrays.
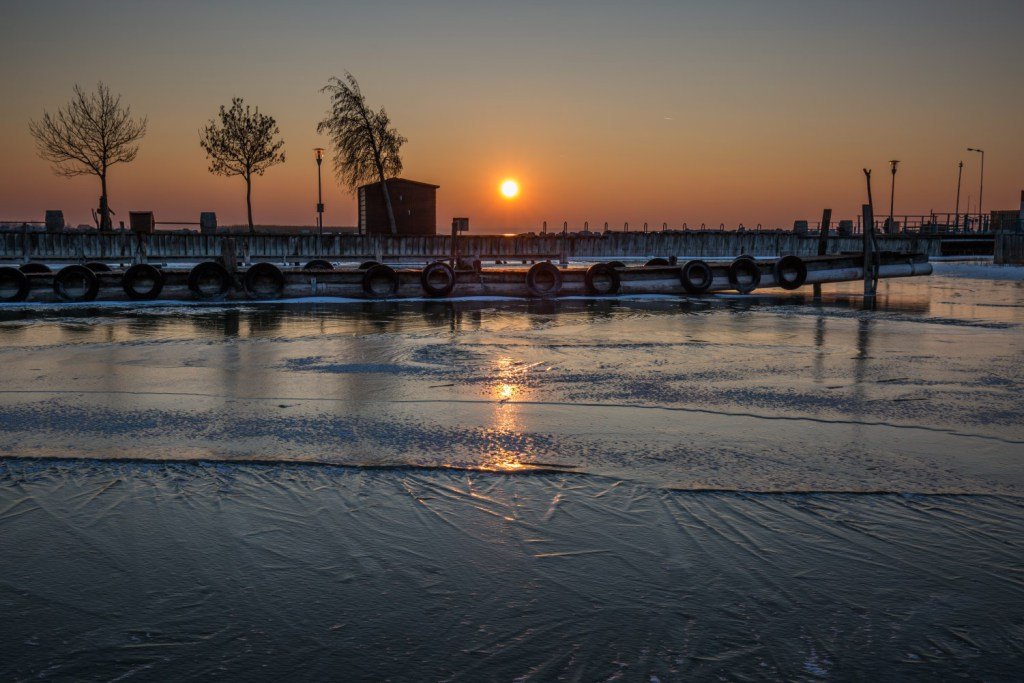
[[0, 230, 943, 262]]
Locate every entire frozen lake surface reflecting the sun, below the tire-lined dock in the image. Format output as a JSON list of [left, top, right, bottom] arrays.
[[0, 263, 1024, 681]]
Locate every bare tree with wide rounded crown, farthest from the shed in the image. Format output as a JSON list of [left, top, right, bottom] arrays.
[[29, 83, 145, 230]]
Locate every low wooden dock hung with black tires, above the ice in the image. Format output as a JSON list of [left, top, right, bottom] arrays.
[[0, 249, 932, 303]]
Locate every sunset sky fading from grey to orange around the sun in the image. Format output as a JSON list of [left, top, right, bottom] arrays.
[[0, 0, 1024, 231]]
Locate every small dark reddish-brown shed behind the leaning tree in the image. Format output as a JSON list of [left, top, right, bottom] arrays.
[[358, 178, 440, 234]]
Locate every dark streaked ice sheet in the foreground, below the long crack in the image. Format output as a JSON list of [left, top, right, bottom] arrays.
[[0, 461, 1024, 681]]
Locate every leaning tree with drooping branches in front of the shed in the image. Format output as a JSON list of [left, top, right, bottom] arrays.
[[316, 72, 406, 234]]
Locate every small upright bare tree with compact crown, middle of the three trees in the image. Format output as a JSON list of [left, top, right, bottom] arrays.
[[199, 97, 285, 233]]
